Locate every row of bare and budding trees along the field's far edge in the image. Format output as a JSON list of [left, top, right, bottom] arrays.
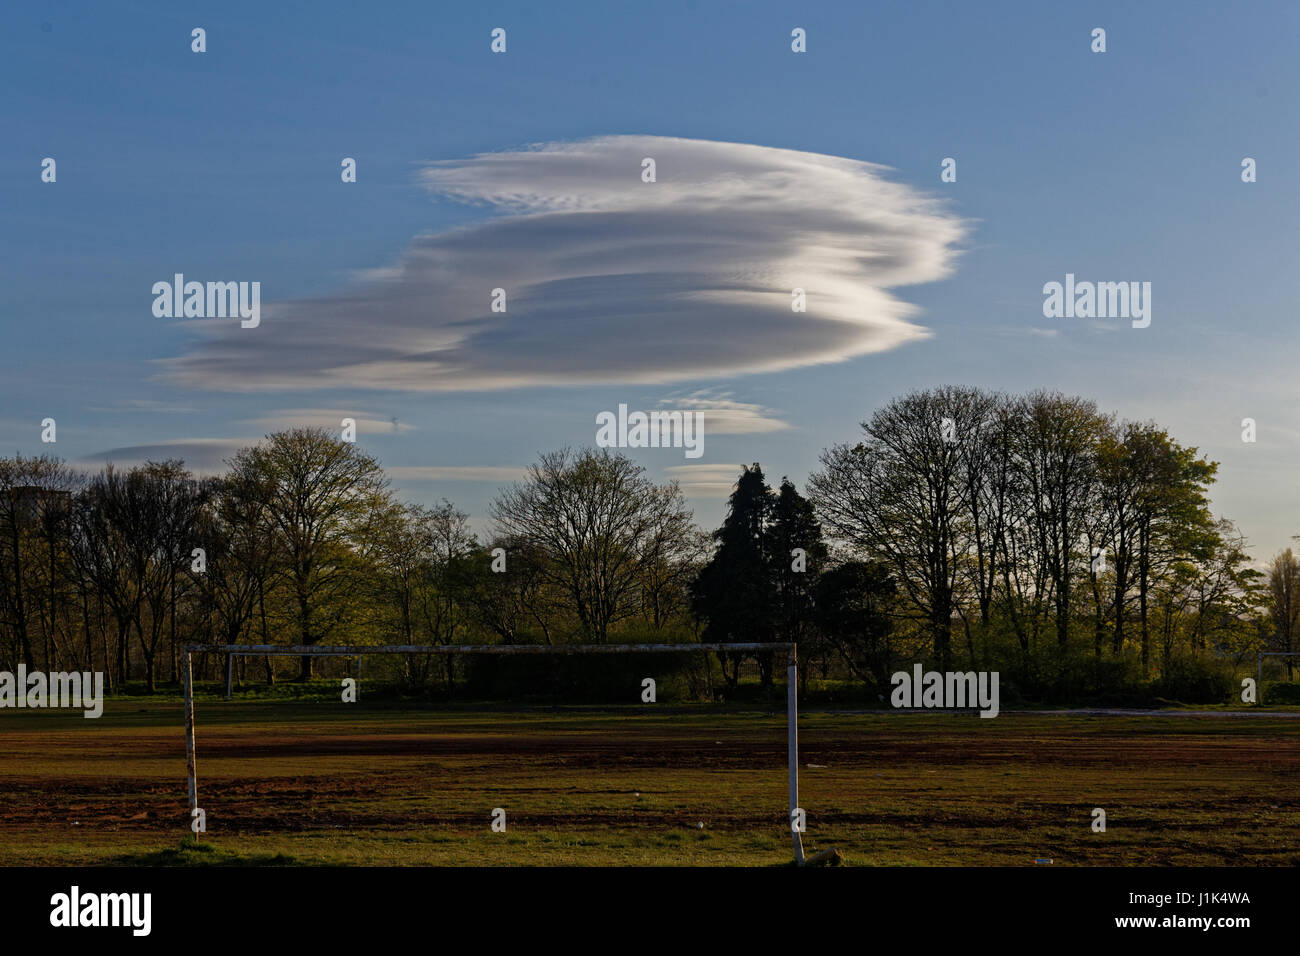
[[0, 386, 1300, 700]]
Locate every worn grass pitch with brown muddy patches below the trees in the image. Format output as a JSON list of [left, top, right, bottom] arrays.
[[0, 700, 1300, 866]]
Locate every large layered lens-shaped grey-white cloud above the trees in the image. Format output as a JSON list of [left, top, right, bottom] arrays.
[[165, 137, 965, 390]]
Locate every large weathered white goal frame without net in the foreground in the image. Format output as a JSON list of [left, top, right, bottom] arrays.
[[181, 643, 815, 866]]
